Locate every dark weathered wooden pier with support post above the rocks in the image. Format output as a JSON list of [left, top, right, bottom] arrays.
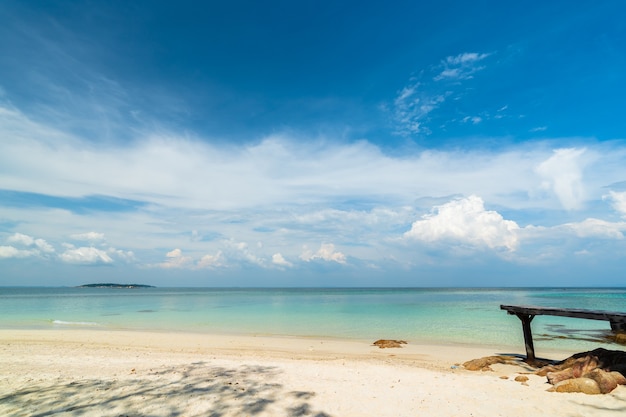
[[500, 305, 626, 362]]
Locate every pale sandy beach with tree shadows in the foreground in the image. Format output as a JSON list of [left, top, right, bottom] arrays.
[[0, 329, 626, 417]]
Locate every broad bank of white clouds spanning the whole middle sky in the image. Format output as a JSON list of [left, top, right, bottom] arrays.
[[0, 103, 626, 282]]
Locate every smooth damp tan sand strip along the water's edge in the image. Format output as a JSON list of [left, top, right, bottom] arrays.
[[0, 328, 580, 366]]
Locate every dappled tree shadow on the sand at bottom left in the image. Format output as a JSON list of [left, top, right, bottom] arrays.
[[0, 362, 330, 417]]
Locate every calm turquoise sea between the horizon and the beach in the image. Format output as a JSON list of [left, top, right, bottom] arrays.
[[0, 287, 626, 353]]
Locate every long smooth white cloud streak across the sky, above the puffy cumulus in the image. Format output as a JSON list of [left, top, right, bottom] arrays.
[[6, 103, 626, 214]]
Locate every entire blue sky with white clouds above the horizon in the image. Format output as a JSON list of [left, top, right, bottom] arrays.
[[0, 0, 626, 287]]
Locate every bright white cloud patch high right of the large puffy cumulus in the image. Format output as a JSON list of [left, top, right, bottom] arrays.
[[536, 148, 586, 210]]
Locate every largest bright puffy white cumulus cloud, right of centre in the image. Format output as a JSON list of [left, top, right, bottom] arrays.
[[404, 195, 519, 251]]
